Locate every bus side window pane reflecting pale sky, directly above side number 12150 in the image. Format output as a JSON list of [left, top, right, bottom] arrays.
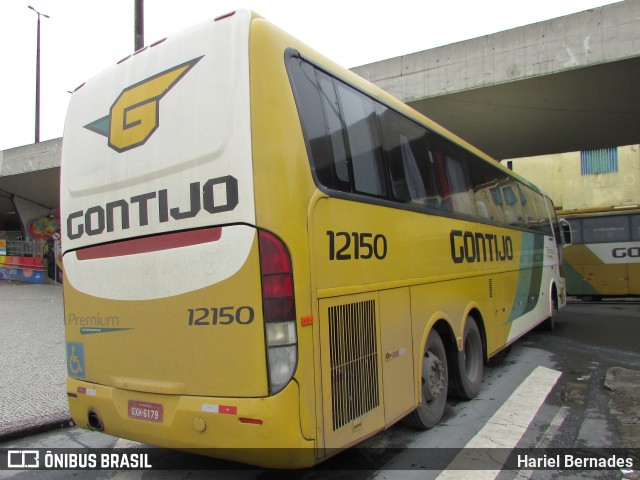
[[335, 82, 387, 197]]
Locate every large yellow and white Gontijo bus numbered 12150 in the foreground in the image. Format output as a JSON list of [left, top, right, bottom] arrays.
[[61, 11, 565, 468]]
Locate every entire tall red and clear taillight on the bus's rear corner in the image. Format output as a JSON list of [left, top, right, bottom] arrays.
[[259, 231, 298, 394]]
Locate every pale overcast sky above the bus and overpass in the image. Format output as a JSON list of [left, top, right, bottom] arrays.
[[0, 0, 613, 150]]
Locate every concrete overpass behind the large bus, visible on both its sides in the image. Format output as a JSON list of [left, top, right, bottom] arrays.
[[0, 0, 640, 215]]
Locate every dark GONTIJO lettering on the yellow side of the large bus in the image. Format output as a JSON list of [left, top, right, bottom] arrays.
[[449, 230, 513, 263]]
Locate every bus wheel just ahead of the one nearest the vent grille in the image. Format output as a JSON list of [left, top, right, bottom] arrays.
[[450, 316, 484, 400]]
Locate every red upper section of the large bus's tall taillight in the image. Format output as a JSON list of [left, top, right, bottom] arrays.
[[259, 231, 296, 323]]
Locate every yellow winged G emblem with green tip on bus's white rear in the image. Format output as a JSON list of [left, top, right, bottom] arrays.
[[85, 57, 202, 152]]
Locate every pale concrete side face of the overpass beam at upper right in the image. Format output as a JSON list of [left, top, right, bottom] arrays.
[[352, 0, 640, 102]]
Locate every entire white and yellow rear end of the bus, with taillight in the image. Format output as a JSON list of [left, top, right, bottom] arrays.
[[61, 12, 315, 466]]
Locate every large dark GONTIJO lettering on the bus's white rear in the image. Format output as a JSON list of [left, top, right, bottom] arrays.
[[67, 175, 238, 240]]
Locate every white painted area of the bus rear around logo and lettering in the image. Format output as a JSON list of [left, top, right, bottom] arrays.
[[61, 11, 255, 299]]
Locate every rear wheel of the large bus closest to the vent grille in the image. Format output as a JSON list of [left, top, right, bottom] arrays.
[[406, 330, 449, 429]]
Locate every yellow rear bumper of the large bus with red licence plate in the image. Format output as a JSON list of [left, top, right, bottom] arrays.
[[67, 377, 319, 468]]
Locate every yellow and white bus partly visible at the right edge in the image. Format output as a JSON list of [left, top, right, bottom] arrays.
[[557, 205, 640, 300]]
